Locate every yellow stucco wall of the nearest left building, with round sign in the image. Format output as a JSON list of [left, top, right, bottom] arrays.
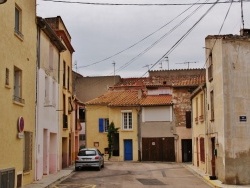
[[0, 0, 36, 185]]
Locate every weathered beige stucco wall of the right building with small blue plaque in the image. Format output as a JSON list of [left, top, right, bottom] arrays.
[[206, 37, 250, 184]]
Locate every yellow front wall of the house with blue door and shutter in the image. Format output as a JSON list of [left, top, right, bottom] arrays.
[[86, 105, 138, 161]]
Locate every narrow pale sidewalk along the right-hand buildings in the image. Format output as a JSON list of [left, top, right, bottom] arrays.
[[183, 163, 250, 188]]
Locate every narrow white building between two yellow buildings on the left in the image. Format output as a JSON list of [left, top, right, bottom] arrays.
[[35, 17, 65, 180]]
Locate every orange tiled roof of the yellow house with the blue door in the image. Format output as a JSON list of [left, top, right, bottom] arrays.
[[86, 90, 141, 106]]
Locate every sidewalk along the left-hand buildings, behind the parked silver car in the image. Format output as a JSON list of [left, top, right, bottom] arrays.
[[23, 167, 74, 188]]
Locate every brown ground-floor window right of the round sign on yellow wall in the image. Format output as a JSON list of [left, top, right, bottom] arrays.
[[23, 131, 33, 172]]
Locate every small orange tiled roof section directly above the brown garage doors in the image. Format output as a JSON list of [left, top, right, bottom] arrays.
[[140, 95, 172, 106]]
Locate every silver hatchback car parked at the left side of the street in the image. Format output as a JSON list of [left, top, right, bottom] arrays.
[[75, 148, 104, 171]]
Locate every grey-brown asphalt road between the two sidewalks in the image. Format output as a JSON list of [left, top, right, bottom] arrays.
[[54, 162, 210, 188]]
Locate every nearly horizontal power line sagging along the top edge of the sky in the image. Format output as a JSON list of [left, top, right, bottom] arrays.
[[42, 0, 250, 6]]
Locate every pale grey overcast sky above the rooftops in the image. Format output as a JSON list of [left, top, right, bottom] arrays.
[[37, 0, 250, 77]]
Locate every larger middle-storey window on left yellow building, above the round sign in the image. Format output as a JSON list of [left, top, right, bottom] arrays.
[[13, 67, 24, 103]]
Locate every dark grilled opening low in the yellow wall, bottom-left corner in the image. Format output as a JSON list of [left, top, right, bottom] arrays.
[[0, 168, 15, 188]]
